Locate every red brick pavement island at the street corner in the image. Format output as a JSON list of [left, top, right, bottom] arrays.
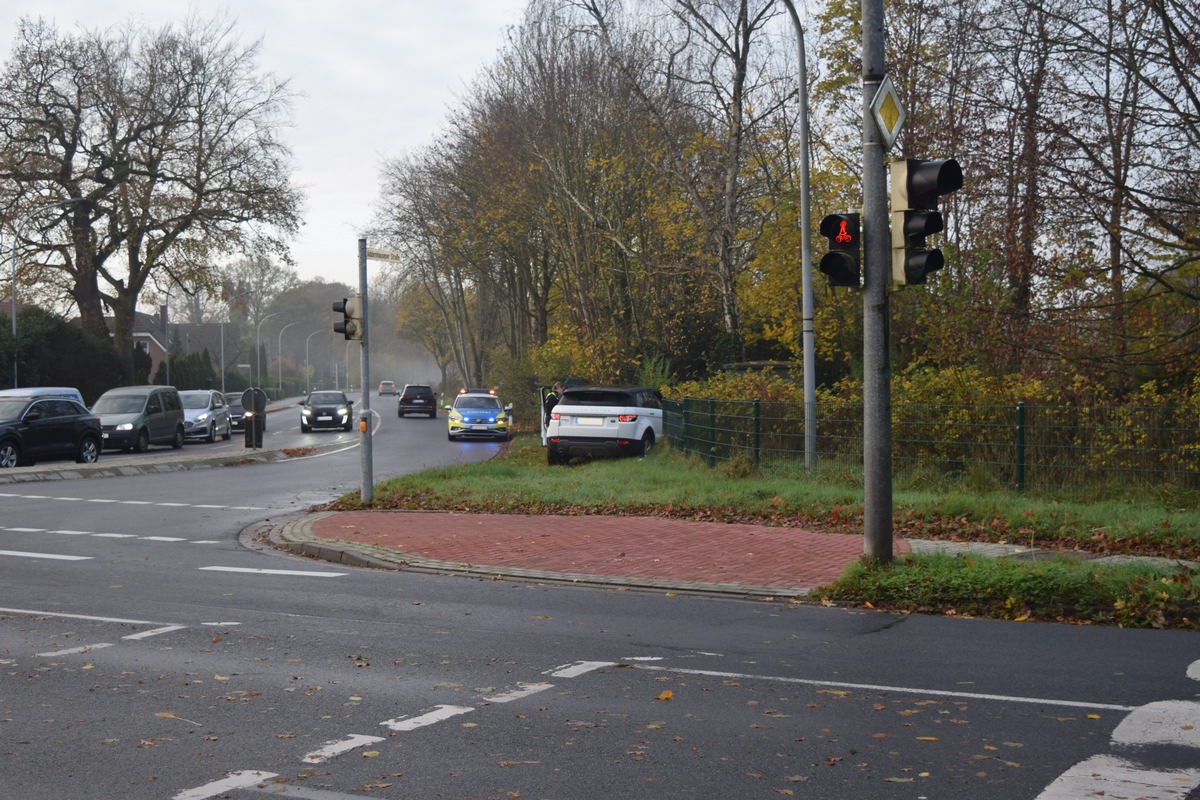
[[312, 511, 907, 589]]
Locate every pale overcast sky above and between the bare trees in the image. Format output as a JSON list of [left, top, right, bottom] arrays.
[[0, 0, 526, 285]]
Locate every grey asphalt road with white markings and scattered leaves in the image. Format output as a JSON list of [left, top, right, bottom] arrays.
[[0, 397, 1200, 800]]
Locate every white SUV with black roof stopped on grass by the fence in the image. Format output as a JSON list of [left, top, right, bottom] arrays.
[[542, 386, 662, 465]]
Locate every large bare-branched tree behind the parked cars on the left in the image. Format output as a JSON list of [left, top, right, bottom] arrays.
[[0, 17, 300, 376]]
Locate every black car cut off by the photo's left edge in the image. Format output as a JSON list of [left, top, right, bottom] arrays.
[[0, 397, 103, 468]]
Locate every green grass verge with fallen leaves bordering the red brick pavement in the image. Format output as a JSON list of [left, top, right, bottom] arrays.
[[328, 435, 1200, 630]]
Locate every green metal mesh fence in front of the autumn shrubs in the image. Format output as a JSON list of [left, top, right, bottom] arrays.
[[664, 397, 1200, 489]]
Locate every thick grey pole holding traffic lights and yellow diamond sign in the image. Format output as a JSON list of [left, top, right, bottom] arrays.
[[862, 0, 892, 564]]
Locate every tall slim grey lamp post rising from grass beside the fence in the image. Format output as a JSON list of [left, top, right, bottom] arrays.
[[784, 0, 817, 470]]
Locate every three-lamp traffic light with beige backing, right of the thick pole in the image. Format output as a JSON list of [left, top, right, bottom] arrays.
[[890, 158, 962, 285]]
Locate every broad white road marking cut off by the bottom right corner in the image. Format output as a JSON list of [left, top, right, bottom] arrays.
[[1036, 754, 1200, 800]]
